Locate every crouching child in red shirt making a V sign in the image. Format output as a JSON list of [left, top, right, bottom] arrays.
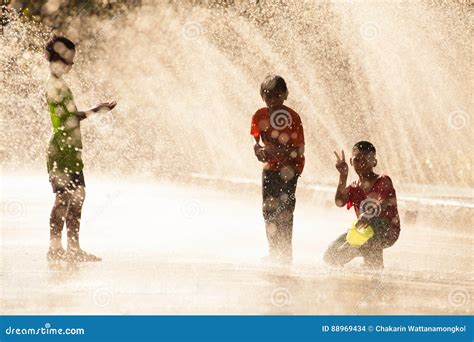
[[324, 141, 400, 269]]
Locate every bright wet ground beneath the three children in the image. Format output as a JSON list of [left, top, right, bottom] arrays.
[[0, 174, 474, 314]]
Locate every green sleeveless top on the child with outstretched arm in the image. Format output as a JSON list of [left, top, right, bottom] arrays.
[[46, 76, 85, 174]]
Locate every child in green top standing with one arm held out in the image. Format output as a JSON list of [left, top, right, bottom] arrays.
[[46, 37, 116, 261]]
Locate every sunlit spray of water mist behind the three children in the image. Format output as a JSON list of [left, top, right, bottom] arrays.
[[0, 1, 473, 192]]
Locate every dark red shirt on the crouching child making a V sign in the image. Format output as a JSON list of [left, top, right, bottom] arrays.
[[346, 175, 400, 240]]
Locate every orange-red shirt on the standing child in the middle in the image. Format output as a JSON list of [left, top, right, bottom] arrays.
[[250, 106, 305, 174]]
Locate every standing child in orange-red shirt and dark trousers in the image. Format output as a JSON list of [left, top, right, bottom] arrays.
[[250, 75, 305, 263]]
